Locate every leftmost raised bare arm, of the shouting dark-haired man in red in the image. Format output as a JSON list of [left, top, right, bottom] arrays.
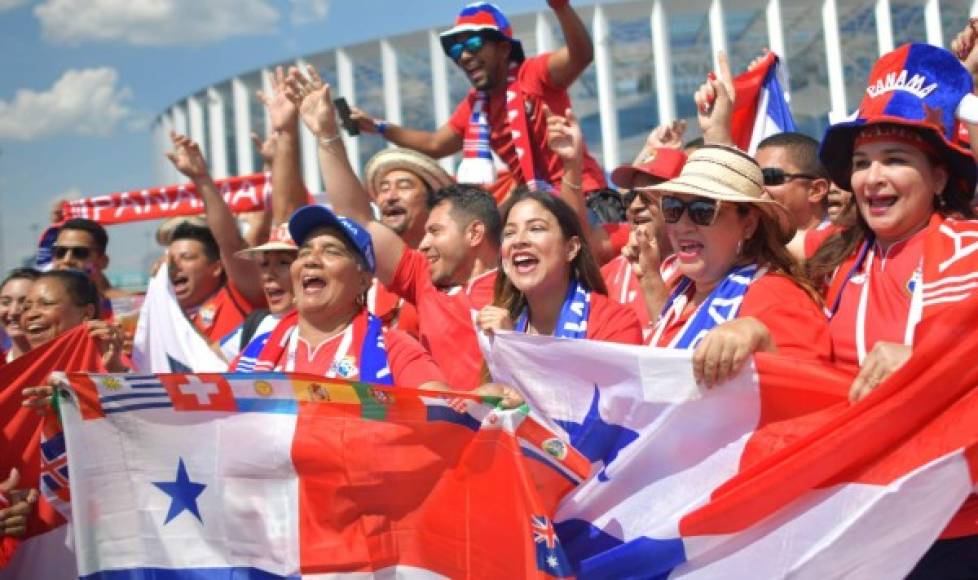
[[166, 133, 264, 304]]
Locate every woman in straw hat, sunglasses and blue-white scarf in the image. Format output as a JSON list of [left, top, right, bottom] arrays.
[[649, 145, 830, 386]]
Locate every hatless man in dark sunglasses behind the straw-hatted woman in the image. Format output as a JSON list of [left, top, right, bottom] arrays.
[[754, 132, 832, 260]]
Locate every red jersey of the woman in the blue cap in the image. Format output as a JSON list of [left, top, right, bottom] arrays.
[[293, 329, 445, 389]]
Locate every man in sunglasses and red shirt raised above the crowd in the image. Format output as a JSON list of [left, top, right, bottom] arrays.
[[344, 0, 605, 191]]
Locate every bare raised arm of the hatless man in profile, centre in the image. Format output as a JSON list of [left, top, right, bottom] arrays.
[[288, 67, 407, 284]]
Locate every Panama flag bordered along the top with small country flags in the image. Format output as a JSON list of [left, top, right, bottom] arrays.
[[57, 373, 590, 580]]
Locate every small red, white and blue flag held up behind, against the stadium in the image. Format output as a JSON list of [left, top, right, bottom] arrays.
[[731, 52, 795, 155]]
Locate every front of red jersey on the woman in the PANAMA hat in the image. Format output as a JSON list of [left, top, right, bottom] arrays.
[[827, 230, 926, 368]]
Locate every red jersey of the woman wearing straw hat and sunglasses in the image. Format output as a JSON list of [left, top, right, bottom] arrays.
[[653, 273, 832, 361]]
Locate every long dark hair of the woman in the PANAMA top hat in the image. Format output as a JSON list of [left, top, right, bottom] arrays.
[[805, 135, 975, 284]]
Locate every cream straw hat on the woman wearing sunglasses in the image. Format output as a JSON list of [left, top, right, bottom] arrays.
[[642, 145, 795, 243]]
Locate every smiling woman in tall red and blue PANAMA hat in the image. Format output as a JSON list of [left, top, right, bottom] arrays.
[[808, 44, 978, 578]]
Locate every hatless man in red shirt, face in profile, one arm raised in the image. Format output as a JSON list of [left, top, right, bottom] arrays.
[[289, 70, 502, 390]]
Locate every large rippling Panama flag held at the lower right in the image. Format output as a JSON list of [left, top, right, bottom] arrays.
[[489, 306, 978, 579]]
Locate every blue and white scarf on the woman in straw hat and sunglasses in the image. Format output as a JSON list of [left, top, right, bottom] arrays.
[[652, 264, 767, 349]]
